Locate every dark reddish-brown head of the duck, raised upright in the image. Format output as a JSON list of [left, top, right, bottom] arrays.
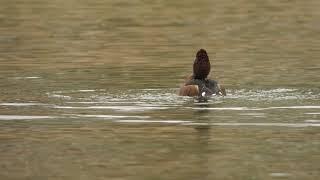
[[193, 49, 210, 79]]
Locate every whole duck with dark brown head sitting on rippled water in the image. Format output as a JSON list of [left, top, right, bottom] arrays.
[[179, 49, 227, 97]]
